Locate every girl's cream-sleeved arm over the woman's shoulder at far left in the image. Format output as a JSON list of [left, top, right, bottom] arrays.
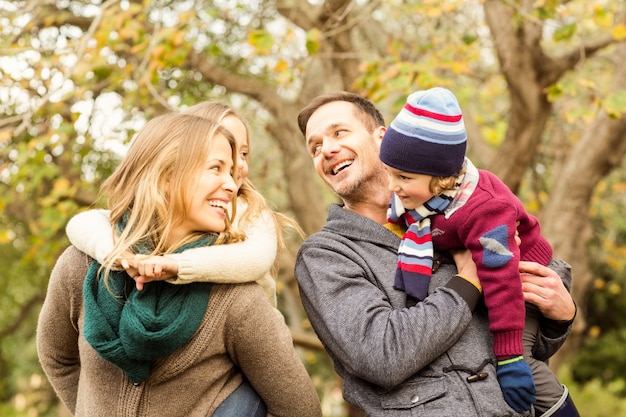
[[65, 209, 113, 264]]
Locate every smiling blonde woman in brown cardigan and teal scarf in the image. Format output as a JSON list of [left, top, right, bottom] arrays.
[[37, 114, 321, 417]]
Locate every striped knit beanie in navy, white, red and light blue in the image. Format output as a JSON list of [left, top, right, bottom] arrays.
[[380, 87, 467, 177]]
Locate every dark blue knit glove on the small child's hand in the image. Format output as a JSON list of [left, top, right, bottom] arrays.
[[496, 356, 536, 413]]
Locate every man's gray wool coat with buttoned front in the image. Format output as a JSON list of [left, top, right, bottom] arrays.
[[295, 205, 570, 417]]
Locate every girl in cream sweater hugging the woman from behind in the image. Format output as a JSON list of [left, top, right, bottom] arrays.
[[66, 102, 302, 306]]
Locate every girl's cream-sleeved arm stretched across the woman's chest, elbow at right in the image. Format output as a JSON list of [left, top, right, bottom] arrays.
[[165, 207, 278, 284]]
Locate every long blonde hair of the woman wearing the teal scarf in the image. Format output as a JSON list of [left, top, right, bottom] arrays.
[[101, 113, 242, 275]]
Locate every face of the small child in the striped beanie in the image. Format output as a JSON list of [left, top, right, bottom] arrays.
[[385, 165, 434, 210]]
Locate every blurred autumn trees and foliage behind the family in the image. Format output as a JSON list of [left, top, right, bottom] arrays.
[[0, 0, 626, 416]]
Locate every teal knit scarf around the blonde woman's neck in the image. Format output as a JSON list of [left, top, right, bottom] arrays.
[[83, 219, 215, 383]]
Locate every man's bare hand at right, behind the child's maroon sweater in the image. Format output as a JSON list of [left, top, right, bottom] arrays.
[[519, 261, 576, 320]]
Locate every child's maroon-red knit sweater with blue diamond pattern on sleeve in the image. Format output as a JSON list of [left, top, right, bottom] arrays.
[[431, 170, 552, 358]]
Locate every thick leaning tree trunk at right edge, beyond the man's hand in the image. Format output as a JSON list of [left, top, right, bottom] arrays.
[[542, 43, 626, 369]]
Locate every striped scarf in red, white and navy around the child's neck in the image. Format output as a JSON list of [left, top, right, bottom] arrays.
[[387, 171, 463, 301]]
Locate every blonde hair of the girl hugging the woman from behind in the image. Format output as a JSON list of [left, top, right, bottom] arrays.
[[184, 101, 304, 277]]
